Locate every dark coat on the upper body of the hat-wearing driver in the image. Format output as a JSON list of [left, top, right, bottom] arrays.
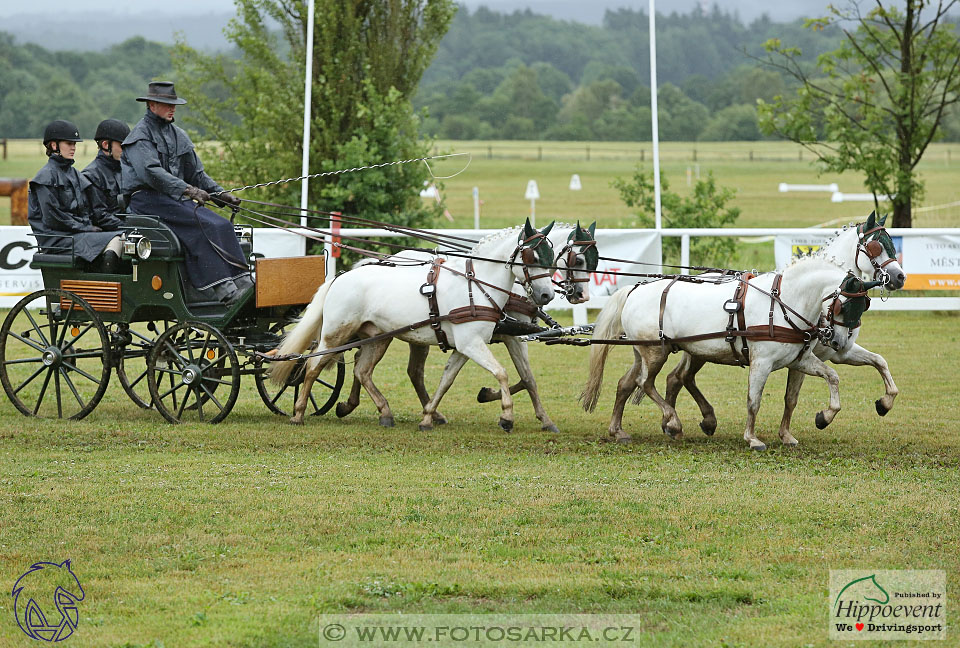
[[120, 110, 223, 200]]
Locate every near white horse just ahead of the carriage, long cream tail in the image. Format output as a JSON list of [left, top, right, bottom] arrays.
[[270, 219, 554, 431]]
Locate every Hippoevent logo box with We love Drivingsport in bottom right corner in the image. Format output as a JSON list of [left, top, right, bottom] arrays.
[[830, 569, 947, 640]]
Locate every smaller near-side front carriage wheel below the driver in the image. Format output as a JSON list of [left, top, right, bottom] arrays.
[[147, 322, 240, 423]]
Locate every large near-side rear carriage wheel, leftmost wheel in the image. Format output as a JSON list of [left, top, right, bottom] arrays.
[[0, 290, 110, 420]]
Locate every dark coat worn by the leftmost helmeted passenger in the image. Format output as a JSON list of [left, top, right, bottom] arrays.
[[27, 155, 120, 261]]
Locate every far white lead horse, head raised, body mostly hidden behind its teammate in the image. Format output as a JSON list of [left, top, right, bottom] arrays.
[[664, 214, 906, 438]]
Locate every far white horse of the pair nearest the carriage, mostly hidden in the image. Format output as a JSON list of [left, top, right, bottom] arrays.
[[336, 222, 599, 433]]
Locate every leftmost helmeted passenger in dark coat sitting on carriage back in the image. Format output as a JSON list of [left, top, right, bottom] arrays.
[[27, 120, 121, 273]]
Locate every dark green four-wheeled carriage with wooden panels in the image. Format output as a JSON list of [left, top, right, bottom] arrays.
[[0, 215, 344, 423]]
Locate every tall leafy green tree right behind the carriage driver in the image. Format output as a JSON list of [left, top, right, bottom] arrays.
[[174, 0, 455, 260]]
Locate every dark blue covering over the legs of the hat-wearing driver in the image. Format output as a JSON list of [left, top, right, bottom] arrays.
[[130, 190, 247, 290]]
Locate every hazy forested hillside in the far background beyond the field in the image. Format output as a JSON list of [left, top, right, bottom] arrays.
[[0, 5, 960, 141]]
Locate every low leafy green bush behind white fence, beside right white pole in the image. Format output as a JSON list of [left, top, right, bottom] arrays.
[[611, 166, 740, 268]]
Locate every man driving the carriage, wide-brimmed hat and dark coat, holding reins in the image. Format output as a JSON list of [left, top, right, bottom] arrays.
[[120, 81, 253, 304]]
